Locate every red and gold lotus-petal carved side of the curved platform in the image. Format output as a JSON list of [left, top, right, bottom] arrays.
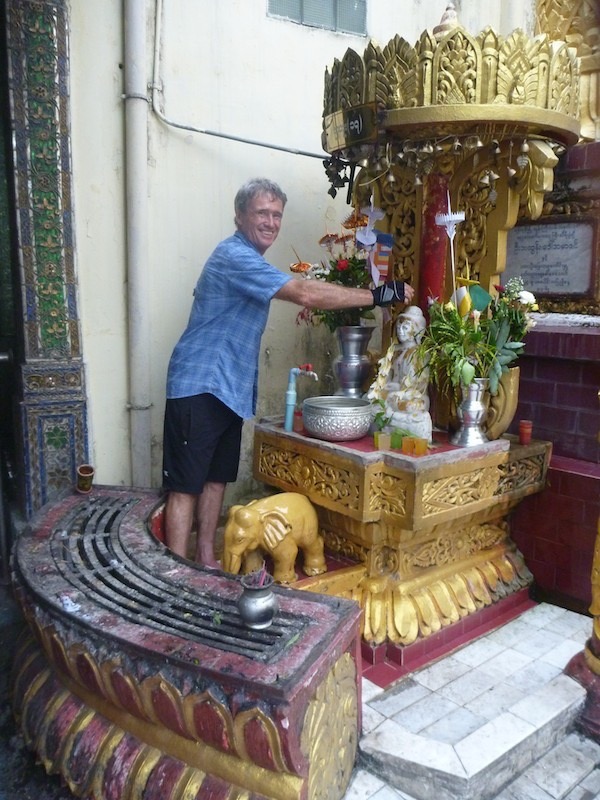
[[13, 634, 358, 800]]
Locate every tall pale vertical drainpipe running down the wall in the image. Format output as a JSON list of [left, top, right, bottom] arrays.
[[123, 0, 151, 487]]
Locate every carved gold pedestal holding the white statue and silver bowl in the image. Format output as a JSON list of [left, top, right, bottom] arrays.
[[254, 421, 551, 646]]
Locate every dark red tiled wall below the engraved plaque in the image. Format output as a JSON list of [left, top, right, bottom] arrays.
[[511, 326, 600, 611]]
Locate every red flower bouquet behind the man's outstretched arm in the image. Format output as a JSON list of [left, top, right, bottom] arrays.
[[290, 214, 374, 333]]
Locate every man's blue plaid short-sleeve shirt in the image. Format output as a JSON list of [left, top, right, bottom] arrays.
[[167, 231, 291, 419]]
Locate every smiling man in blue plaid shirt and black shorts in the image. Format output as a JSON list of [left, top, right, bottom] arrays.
[[163, 179, 414, 567]]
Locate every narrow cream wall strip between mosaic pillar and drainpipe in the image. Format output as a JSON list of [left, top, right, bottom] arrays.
[[71, 0, 129, 484]]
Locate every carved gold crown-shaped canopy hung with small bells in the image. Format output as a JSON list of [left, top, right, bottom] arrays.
[[323, 5, 580, 289]]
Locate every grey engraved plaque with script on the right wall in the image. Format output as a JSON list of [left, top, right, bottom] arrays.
[[502, 219, 597, 296]]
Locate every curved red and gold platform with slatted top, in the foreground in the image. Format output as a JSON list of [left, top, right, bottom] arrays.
[[12, 487, 361, 800]]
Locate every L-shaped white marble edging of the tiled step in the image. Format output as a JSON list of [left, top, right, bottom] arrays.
[[359, 673, 594, 800]]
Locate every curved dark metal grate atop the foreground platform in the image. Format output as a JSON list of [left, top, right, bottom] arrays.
[[50, 497, 309, 662]]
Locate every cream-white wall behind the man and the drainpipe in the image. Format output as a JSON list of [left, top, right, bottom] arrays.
[[71, 0, 527, 498]]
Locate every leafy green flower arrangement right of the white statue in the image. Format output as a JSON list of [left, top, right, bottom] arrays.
[[417, 278, 537, 395]]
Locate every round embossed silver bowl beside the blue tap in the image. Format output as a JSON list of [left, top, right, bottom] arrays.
[[302, 396, 373, 442]]
